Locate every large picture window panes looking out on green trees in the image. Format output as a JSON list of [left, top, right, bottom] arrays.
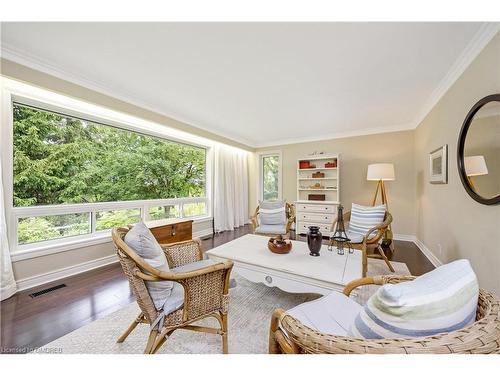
[[12, 103, 208, 250]]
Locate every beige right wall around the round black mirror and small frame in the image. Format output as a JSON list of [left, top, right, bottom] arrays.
[[415, 34, 500, 293]]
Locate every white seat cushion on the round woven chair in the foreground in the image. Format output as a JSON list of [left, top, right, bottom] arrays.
[[288, 292, 363, 336]]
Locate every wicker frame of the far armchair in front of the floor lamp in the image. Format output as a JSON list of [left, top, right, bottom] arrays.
[[330, 211, 394, 277]]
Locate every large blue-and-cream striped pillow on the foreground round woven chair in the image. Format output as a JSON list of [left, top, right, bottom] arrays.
[[348, 259, 479, 339]]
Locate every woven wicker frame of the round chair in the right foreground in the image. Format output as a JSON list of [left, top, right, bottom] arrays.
[[269, 276, 500, 354]]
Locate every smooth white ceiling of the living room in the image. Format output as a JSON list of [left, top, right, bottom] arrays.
[[2, 23, 491, 147]]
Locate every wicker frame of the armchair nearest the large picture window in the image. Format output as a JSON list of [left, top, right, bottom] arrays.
[[112, 228, 233, 354]]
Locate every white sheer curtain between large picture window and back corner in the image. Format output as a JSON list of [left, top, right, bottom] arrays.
[[214, 144, 248, 232]]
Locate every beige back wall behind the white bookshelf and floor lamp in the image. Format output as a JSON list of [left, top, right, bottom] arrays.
[[256, 131, 416, 235]]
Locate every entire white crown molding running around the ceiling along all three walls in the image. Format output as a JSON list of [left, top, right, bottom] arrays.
[[1, 22, 500, 149]]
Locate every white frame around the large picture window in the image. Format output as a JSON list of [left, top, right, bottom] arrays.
[[0, 76, 213, 261]]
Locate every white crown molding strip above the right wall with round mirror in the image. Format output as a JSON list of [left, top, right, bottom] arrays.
[[413, 22, 500, 129]]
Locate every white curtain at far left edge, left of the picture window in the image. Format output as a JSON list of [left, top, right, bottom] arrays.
[[0, 163, 17, 301]]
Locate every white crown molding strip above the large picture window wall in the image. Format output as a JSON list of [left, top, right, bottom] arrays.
[[0, 43, 256, 148]]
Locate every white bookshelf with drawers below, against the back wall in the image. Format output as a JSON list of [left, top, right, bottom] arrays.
[[295, 154, 340, 236]]
